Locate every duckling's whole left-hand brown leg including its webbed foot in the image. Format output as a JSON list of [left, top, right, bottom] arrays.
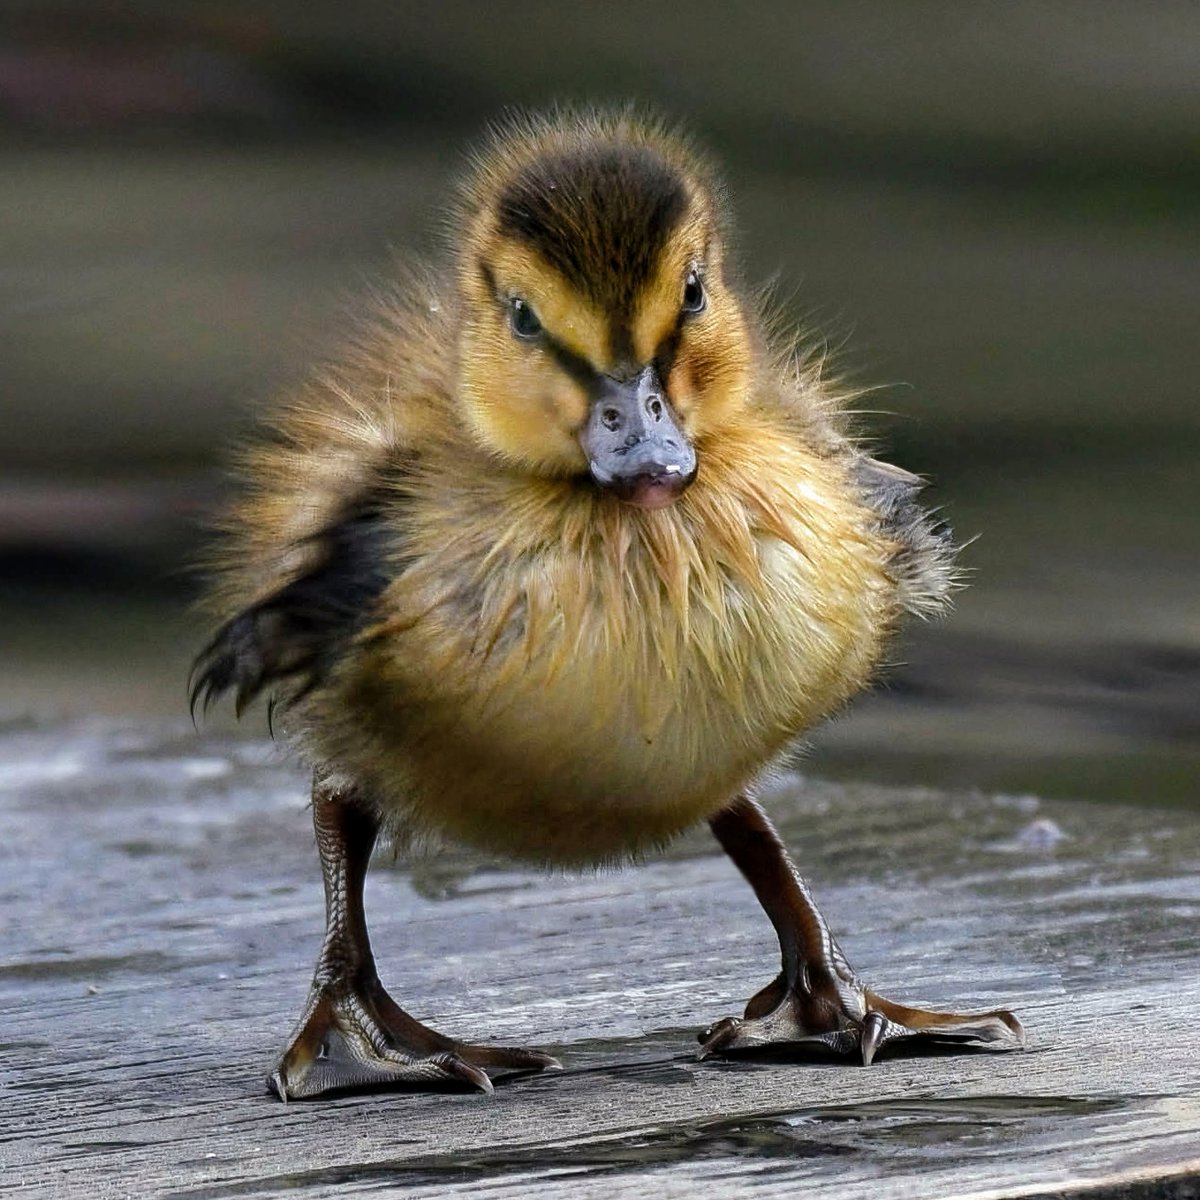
[[268, 778, 559, 1100]]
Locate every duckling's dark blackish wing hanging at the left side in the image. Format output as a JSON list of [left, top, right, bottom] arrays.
[[191, 494, 391, 716]]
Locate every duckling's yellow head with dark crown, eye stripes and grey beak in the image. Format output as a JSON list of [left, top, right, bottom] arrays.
[[457, 113, 751, 508]]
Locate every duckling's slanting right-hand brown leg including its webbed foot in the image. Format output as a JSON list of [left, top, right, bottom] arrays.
[[700, 797, 1025, 1066]]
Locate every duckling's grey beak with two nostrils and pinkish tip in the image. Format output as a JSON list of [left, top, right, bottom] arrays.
[[580, 366, 696, 509]]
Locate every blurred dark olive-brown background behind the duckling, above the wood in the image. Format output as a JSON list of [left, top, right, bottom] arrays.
[[0, 0, 1200, 804]]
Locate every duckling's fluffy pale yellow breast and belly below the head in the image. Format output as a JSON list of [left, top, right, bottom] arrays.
[[302, 412, 896, 863]]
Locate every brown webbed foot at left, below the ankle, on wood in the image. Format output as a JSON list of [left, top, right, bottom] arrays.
[[268, 979, 560, 1100]]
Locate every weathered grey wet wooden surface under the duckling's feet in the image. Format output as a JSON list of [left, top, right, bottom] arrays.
[[0, 725, 1200, 1200]]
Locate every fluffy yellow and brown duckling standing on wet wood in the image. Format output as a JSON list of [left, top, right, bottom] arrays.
[[192, 110, 1022, 1100]]
